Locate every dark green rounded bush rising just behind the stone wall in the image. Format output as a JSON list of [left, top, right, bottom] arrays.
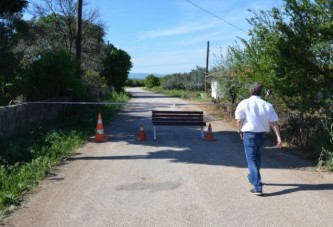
[[25, 50, 82, 100]]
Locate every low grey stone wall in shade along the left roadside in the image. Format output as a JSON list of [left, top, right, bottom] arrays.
[[0, 98, 71, 138]]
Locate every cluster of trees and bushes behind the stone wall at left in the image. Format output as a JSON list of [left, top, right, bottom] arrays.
[[0, 0, 132, 105]]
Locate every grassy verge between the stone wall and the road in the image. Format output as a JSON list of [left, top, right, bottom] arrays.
[[0, 93, 128, 220]]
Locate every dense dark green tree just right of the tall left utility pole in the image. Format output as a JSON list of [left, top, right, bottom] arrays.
[[101, 44, 132, 92]]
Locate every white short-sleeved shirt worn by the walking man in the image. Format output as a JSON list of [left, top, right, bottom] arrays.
[[235, 95, 279, 132]]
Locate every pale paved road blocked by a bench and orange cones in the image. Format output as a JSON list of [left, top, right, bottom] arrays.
[[6, 89, 333, 227]]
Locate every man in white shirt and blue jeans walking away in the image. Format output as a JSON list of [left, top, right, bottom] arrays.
[[235, 82, 282, 195]]
